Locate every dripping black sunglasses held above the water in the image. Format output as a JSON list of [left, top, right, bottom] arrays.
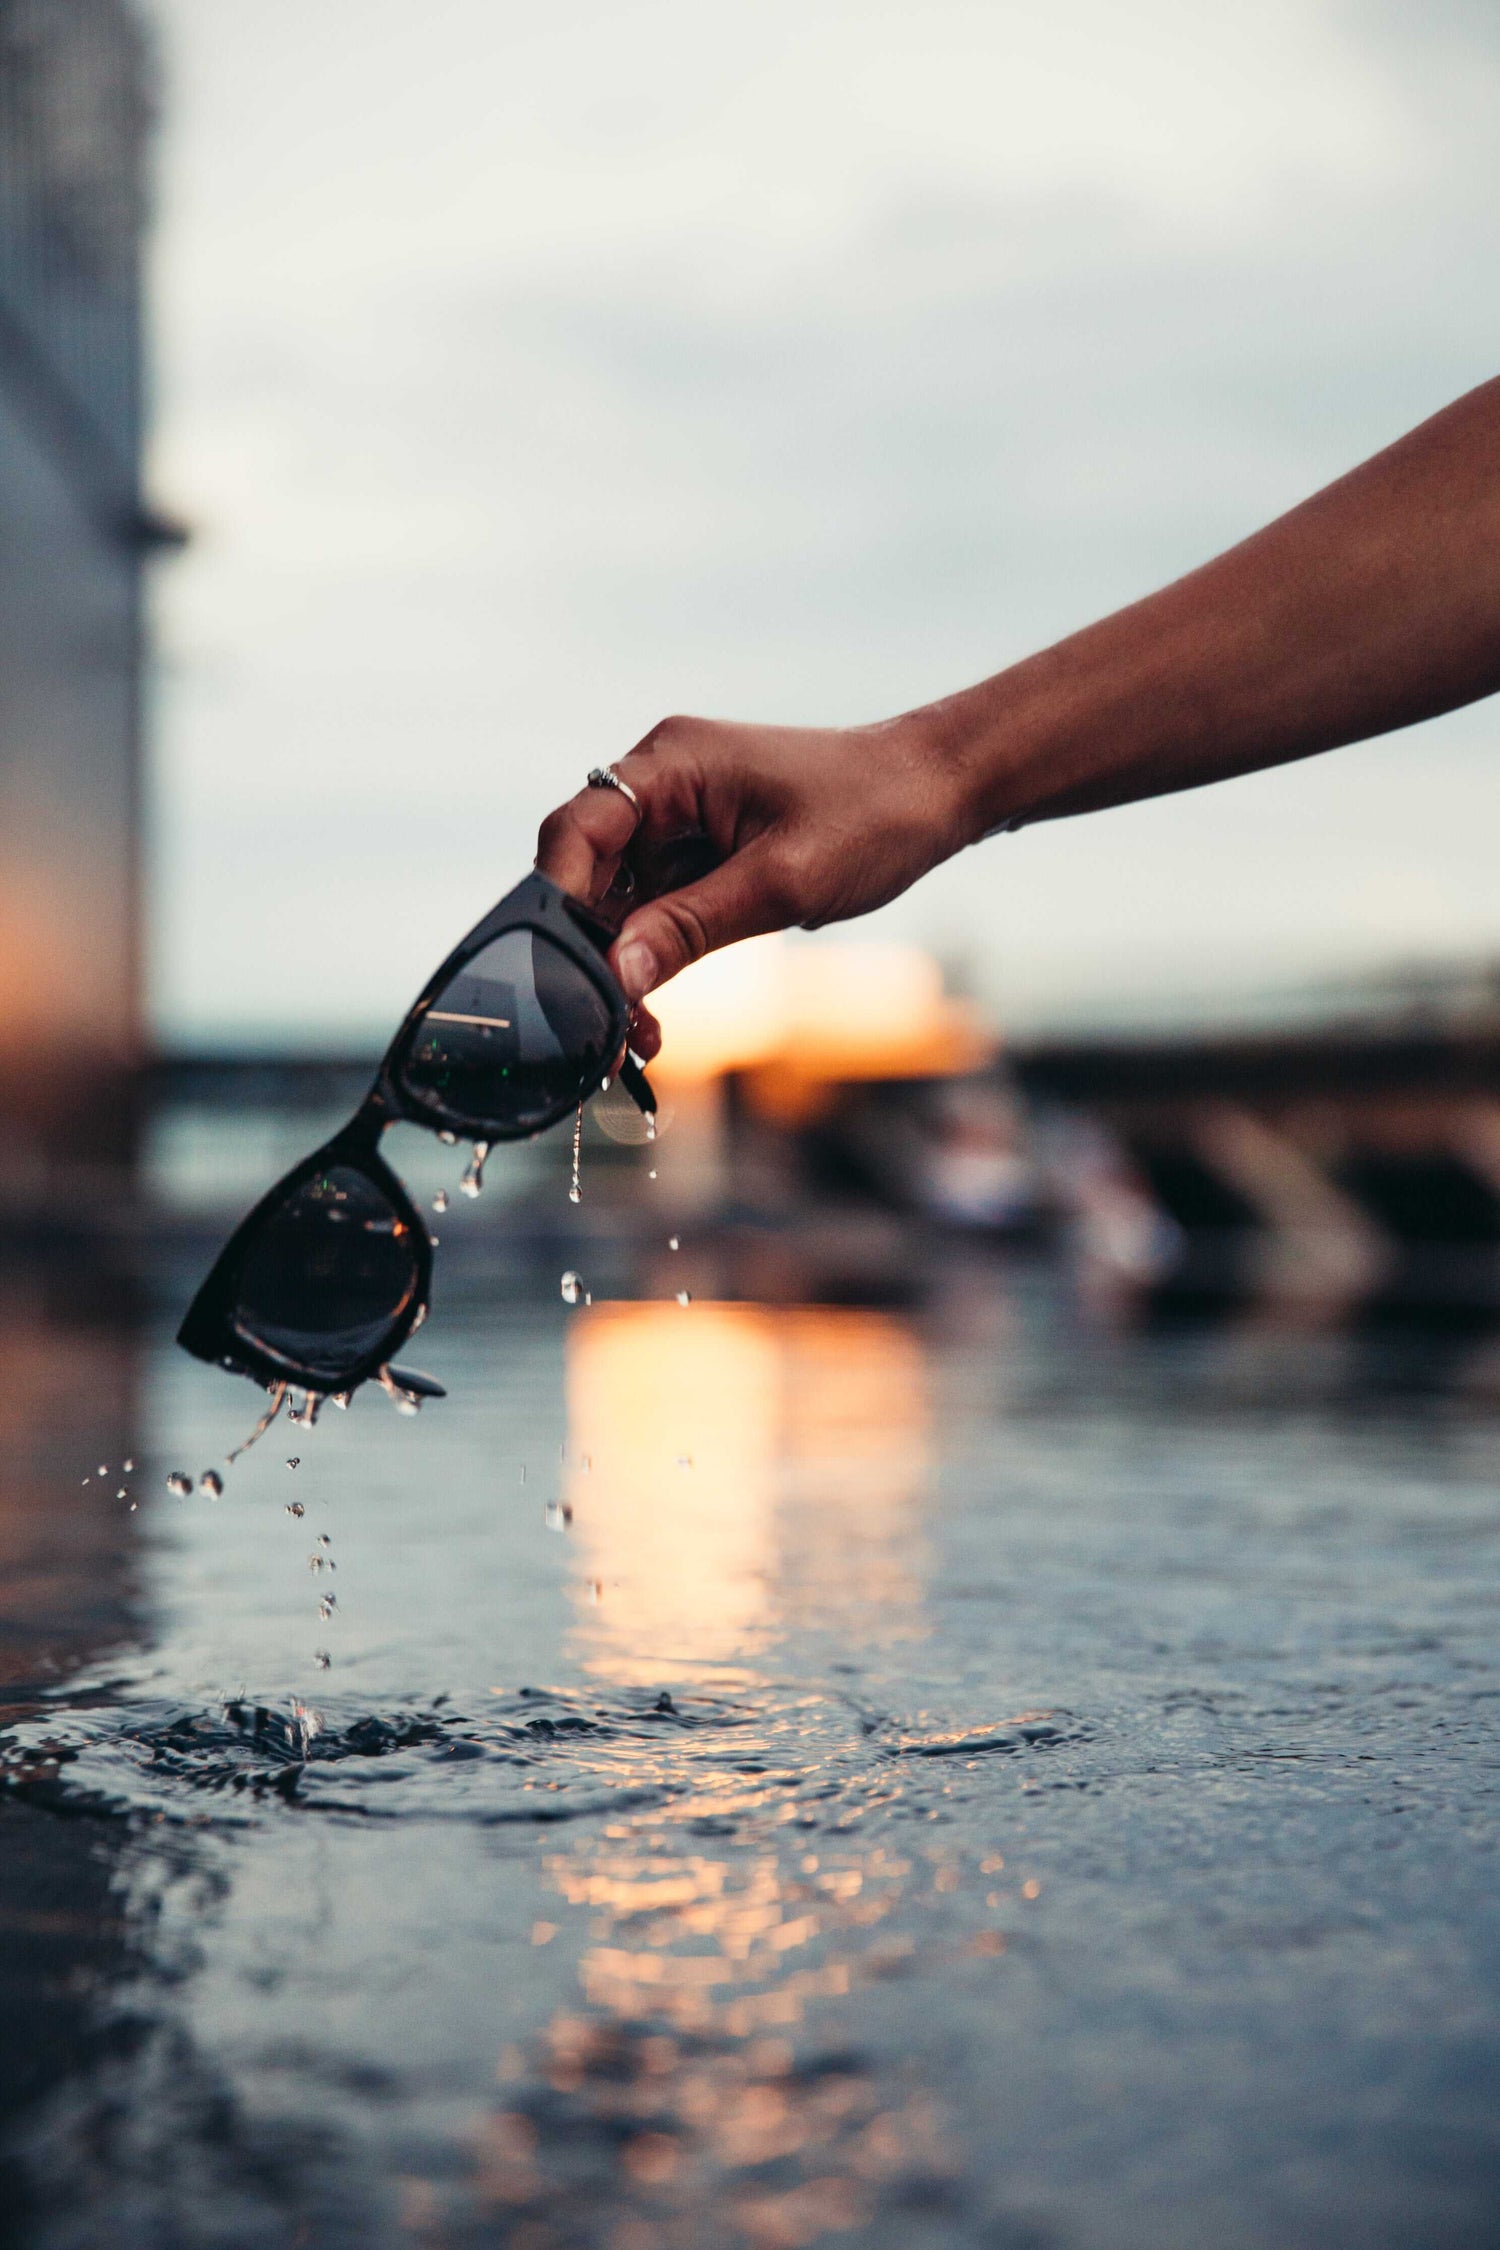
[[178, 875, 657, 1415]]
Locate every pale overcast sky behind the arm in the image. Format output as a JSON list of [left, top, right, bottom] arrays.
[[153, 0, 1500, 1037]]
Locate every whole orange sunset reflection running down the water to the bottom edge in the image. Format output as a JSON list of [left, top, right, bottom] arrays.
[[463, 1305, 951, 2250]]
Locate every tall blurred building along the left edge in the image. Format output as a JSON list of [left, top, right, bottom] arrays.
[[0, 0, 162, 1199]]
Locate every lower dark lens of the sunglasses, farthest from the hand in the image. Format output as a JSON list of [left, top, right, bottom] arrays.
[[234, 1163, 418, 1384]]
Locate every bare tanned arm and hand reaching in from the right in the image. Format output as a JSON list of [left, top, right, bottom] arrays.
[[537, 380, 1500, 1058]]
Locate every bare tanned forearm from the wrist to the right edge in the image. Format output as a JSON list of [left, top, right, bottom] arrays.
[[926, 380, 1500, 842]]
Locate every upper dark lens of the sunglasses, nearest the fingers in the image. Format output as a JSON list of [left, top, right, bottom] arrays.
[[398, 929, 612, 1136]]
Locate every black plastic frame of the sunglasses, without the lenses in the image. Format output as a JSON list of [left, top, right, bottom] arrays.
[[178, 871, 657, 1397]]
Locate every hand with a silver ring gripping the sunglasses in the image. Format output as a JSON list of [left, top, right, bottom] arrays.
[[537, 716, 969, 1053]]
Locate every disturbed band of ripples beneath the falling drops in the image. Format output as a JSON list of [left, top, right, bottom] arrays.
[[0, 1688, 1084, 1836]]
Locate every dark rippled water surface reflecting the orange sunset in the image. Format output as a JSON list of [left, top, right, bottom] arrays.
[[0, 1179, 1500, 2250]]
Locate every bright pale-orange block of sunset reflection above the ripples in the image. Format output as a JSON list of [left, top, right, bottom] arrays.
[[569, 1305, 927, 1681]]
